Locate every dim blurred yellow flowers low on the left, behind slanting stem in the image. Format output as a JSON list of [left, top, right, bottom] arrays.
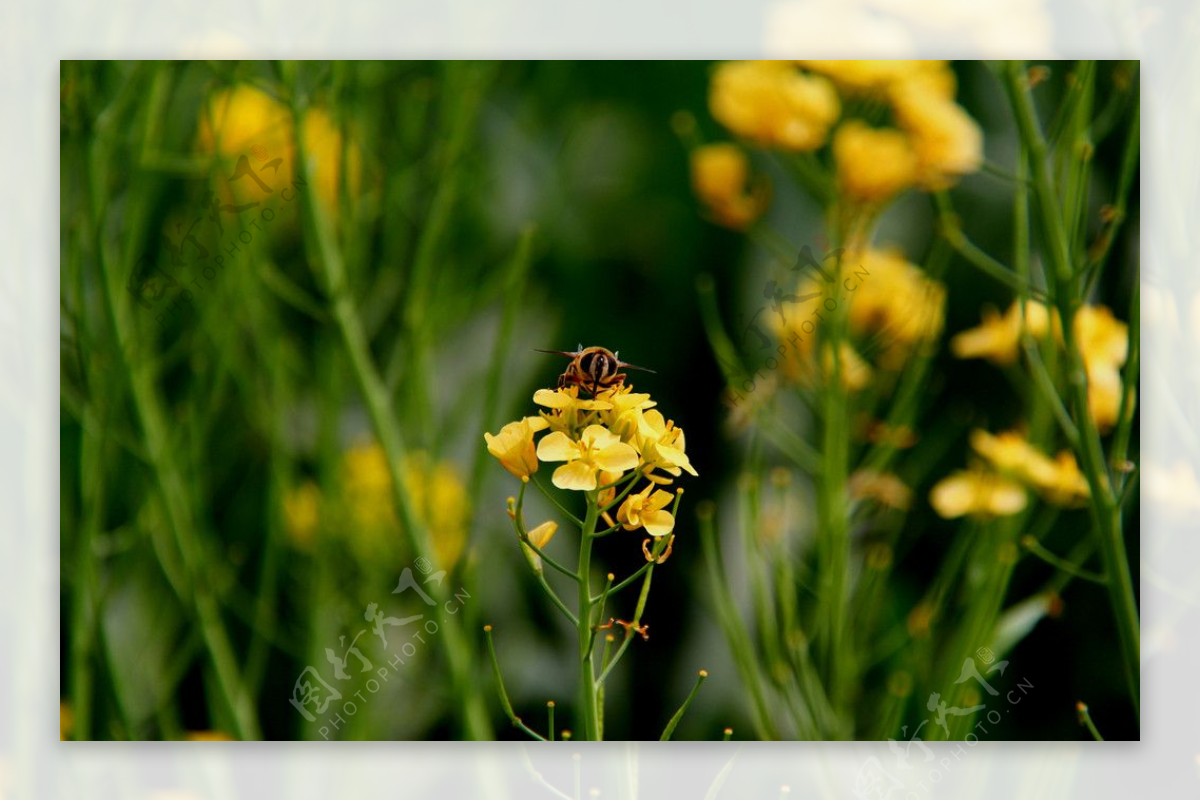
[[283, 442, 469, 570]]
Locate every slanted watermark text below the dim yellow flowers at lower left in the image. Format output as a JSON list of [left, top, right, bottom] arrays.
[[288, 556, 470, 740]]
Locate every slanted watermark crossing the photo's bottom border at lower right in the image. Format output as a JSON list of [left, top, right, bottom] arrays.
[[854, 648, 1033, 799]]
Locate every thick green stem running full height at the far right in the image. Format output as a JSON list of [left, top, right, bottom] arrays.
[[1004, 61, 1141, 711]]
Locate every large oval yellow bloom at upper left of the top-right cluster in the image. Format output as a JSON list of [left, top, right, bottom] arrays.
[[708, 61, 841, 151]]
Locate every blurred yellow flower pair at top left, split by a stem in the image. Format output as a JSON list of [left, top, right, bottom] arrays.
[[197, 84, 361, 216]]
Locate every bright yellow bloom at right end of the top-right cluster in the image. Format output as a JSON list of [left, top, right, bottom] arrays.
[[890, 80, 983, 189]]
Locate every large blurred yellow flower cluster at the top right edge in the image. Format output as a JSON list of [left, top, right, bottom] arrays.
[[692, 61, 983, 221]]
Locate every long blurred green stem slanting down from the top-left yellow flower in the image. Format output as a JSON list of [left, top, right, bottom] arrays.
[[293, 87, 492, 740]]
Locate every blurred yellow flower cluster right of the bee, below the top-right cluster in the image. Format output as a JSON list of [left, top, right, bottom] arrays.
[[770, 248, 946, 383]]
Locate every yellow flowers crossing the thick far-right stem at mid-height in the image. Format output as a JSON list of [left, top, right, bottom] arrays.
[[950, 301, 1132, 430]]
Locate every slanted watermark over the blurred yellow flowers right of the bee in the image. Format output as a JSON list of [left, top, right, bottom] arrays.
[[718, 245, 871, 409]]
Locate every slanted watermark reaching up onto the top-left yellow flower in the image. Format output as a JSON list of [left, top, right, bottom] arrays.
[[126, 145, 307, 330]]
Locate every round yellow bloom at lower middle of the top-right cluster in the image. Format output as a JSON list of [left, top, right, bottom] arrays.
[[833, 120, 917, 203]]
